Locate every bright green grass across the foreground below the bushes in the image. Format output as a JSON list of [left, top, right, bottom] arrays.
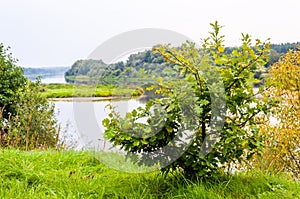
[[0, 149, 300, 199]]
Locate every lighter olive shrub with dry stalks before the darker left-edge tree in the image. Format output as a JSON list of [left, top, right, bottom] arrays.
[[0, 83, 59, 150]]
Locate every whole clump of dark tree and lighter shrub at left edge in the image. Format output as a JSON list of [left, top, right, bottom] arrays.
[[0, 43, 58, 150]]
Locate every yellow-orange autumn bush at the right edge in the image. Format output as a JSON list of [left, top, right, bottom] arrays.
[[255, 49, 300, 176]]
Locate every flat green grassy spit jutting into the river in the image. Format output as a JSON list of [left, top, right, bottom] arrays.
[[41, 83, 142, 98]]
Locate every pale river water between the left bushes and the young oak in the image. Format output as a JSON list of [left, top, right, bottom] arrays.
[[54, 99, 145, 150]]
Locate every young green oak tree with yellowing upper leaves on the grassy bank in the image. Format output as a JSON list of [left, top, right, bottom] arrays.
[[103, 22, 270, 178]]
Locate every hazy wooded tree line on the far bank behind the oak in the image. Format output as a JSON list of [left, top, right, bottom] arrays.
[[65, 42, 300, 84]]
